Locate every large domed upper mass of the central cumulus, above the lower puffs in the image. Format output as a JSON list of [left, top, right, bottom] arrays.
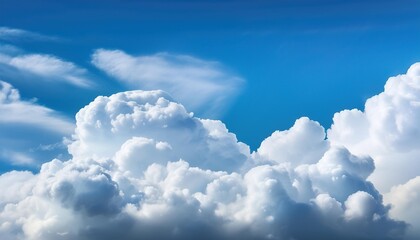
[[69, 91, 249, 171]]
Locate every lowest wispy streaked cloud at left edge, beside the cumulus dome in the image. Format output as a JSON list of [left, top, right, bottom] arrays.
[[0, 81, 74, 165]]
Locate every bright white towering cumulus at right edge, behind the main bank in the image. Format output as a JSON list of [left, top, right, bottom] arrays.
[[328, 63, 420, 239]]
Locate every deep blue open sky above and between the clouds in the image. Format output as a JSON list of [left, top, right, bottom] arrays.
[[0, 0, 420, 151]]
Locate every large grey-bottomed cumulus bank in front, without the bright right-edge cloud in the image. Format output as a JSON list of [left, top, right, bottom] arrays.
[[0, 88, 406, 240]]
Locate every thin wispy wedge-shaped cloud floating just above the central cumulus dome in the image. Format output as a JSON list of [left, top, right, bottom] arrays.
[[92, 49, 244, 115]]
